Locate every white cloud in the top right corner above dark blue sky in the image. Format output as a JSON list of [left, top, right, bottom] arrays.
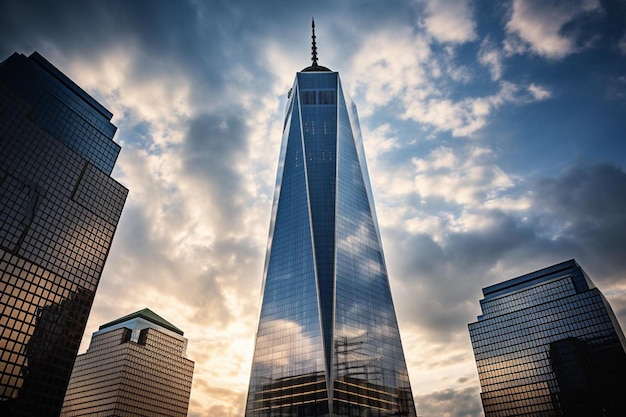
[[505, 0, 601, 59]]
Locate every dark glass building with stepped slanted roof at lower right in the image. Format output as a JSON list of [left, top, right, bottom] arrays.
[[469, 260, 626, 417]]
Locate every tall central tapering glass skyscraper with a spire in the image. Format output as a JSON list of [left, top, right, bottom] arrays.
[[246, 21, 415, 417]]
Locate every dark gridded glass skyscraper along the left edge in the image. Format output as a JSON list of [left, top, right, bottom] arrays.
[[0, 52, 128, 417]]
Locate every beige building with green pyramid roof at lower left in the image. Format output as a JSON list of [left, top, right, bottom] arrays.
[[61, 309, 194, 417]]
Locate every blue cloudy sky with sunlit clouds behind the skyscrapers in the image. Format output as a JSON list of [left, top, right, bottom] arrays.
[[0, 0, 626, 417]]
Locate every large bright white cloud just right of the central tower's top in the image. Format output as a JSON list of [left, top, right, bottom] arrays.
[[349, 14, 551, 137]]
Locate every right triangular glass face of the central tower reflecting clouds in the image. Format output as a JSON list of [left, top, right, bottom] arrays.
[[333, 82, 415, 417]]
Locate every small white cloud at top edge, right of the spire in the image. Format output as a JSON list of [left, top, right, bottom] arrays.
[[421, 0, 476, 43]]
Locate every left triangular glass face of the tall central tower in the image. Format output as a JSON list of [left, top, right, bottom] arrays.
[[246, 91, 328, 417]]
